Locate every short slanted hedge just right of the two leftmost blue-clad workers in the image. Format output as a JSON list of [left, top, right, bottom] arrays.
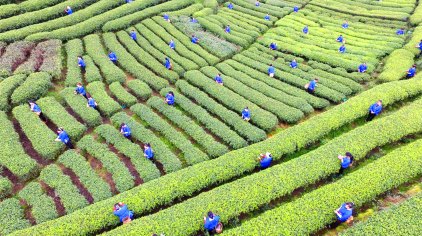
[[37, 95, 86, 141]]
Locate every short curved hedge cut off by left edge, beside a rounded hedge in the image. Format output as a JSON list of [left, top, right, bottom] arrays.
[[0, 75, 26, 111]]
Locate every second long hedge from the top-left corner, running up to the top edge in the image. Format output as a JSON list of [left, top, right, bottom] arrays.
[[0, 0, 95, 32]]
